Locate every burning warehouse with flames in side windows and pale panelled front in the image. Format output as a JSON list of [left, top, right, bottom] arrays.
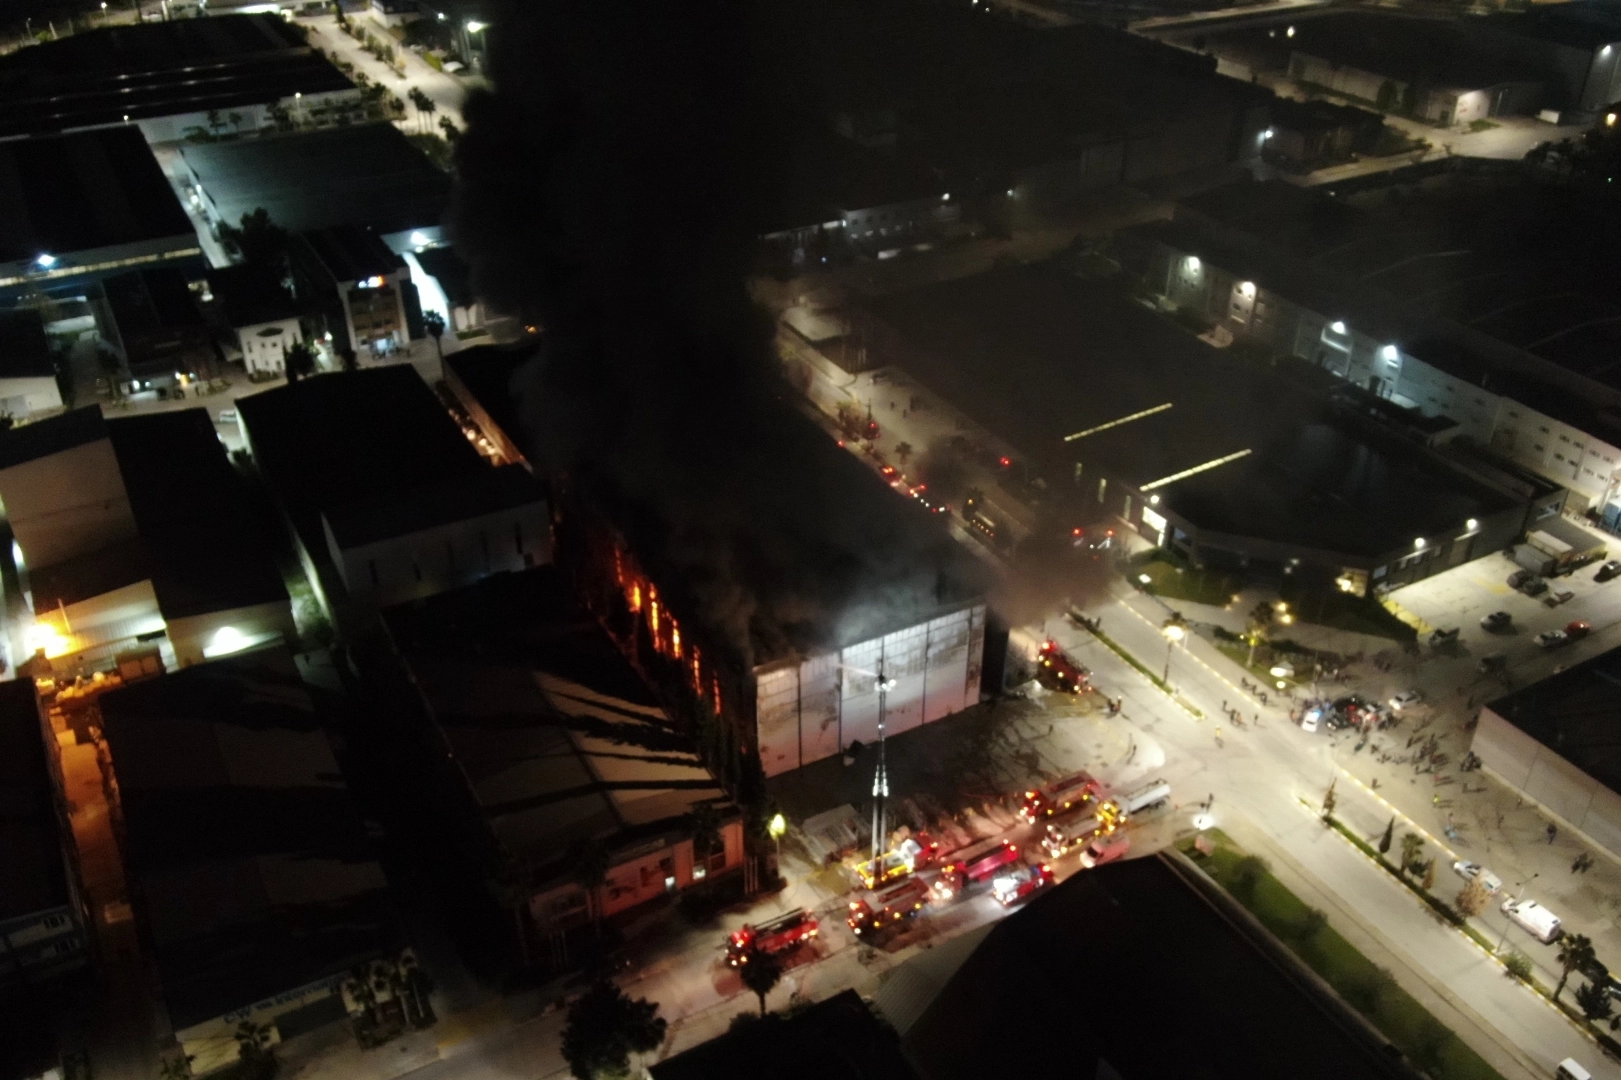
[[446, 352, 1005, 780]]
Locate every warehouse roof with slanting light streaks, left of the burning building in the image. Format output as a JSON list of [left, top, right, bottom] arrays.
[[384, 566, 725, 871]]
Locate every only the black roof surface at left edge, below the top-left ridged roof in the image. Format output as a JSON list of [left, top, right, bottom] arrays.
[[0, 126, 196, 263]]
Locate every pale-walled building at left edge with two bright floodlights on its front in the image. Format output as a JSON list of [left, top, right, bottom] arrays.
[[0, 405, 293, 671]]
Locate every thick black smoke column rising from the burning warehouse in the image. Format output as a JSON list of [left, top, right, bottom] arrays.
[[454, 0, 953, 658]]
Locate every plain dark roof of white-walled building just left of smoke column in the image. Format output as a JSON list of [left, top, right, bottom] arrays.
[[237, 363, 491, 558]]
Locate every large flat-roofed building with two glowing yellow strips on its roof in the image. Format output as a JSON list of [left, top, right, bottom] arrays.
[[869, 266, 1525, 594]]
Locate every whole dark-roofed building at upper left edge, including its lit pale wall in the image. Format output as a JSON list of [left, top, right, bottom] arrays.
[[0, 124, 203, 295]]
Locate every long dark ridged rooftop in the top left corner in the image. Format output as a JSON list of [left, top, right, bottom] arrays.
[[0, 15, 353, 138]]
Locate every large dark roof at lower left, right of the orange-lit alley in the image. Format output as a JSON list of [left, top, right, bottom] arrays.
[[101, 649, 399, 1030]]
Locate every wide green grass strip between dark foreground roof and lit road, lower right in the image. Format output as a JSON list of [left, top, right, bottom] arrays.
[[1177, 829, 1503, 1080]]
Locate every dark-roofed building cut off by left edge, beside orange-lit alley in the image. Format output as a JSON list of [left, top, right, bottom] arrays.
[[0, 678, 89, 989]]
